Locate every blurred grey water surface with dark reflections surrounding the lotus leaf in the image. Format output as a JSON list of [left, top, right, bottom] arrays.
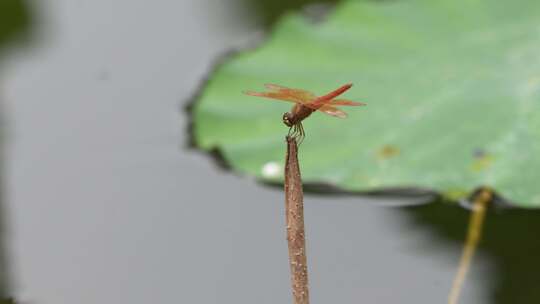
[[0, 0, 540, 304]]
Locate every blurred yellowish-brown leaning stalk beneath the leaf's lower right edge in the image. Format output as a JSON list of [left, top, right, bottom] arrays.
[[448, 188, 493, 304]]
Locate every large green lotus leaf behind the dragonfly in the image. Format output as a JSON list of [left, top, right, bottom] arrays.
[[192, 0, 540, 208]]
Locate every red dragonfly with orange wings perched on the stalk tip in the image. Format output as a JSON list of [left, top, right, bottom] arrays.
[[244, 83, 365, 137]]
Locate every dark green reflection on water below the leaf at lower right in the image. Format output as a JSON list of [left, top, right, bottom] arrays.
[[403, 203, 540, 304]]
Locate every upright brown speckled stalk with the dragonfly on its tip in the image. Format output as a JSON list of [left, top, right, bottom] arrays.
[[285, 136, 309, 304]]
